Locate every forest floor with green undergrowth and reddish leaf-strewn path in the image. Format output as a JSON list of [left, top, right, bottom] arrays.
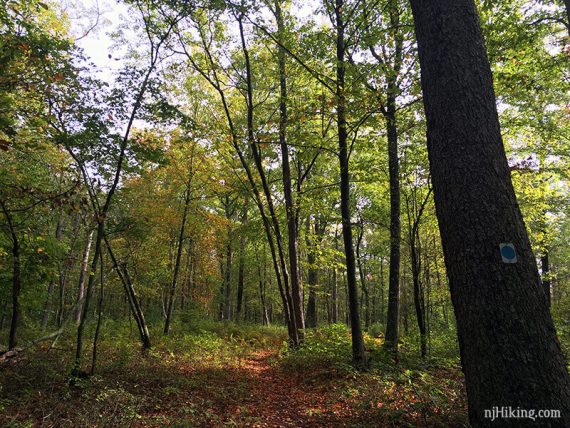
[[0, 326, 467, 427]]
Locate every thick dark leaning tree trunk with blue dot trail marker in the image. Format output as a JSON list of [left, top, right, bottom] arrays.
[[411, 0, 570, 427]]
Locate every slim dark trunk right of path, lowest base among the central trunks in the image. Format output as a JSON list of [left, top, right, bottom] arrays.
[[335, 0, 367, 369]]
